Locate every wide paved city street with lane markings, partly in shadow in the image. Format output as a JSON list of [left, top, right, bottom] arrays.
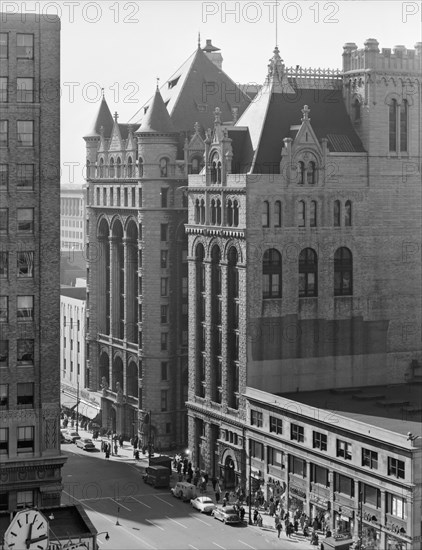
[[62, 443, 310, 550]]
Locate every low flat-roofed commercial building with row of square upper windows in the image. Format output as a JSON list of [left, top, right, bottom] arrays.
[[245, 380, 422, 550]]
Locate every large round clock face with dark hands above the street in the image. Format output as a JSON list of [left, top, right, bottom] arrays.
[[4, 510, 48, 550]]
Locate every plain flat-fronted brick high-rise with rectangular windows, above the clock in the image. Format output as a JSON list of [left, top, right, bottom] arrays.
[[0, 14, 66, 510]]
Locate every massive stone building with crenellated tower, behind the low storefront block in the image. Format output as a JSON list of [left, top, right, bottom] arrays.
[[186, 39, 421, 512]]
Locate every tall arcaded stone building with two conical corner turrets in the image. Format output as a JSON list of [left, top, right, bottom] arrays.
[[84, 41, 249, 448]]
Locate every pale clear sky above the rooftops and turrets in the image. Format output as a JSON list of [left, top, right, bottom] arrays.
[[4, 0, 421, 183]]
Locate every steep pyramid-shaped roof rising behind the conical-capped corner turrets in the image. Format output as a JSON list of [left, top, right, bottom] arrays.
[[132, 48, 250, 132]]
